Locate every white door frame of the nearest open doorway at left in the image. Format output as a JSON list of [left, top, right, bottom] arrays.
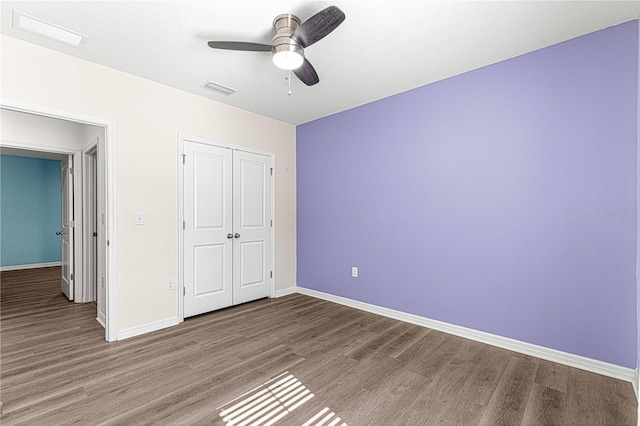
[[0, 97, 118, 342]]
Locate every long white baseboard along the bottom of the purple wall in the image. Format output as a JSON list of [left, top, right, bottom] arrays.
[[297, 286, 638, 384]]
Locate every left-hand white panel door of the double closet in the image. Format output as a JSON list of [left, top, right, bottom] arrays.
[[184, 142, 233, 317]]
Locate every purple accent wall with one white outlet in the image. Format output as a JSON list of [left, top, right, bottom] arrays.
[[297, 21, 638, 368]]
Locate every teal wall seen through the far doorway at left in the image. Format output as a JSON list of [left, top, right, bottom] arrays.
[[0, 155, 62, 266]]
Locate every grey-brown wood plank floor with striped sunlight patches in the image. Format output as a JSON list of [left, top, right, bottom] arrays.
[[0, 268, 637, 426]]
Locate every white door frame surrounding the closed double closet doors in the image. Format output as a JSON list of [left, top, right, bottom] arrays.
[[177, 133, 277, 322]]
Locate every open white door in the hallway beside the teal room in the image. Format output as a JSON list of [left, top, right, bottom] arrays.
[[61, 155, 74, 300]]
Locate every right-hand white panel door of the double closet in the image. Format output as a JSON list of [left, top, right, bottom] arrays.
[[233, 151, 271, 305]]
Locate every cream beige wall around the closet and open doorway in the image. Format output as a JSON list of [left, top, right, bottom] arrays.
[[0, 36, 296, 331]]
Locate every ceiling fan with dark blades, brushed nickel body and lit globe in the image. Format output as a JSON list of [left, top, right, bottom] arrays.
[[208, 6, 345, 86]]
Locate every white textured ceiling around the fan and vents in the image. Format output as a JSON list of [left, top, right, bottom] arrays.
[[0, 0, 639, 124]]
